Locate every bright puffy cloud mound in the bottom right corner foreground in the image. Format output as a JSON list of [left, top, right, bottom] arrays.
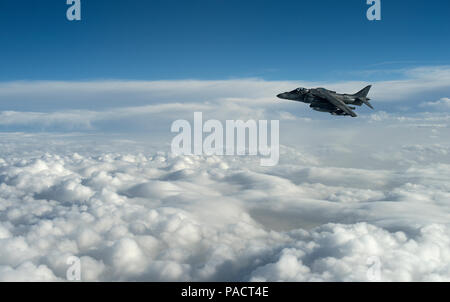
[[250, 223, 450, 282]]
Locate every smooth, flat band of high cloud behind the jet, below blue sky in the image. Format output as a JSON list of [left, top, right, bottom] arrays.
[[0, 66, 450, 131]]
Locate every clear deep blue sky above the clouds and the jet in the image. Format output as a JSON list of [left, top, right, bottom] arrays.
[[0, 0, 450, 82]]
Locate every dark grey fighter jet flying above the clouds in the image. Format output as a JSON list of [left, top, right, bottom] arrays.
[[277, 85, 373, 117]]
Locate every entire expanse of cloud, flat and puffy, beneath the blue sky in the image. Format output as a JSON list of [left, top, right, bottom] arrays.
[[0, 66, 450, 281]]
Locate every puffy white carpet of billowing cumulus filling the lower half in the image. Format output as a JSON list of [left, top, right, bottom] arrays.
[[0, 134, 450, 281]]
